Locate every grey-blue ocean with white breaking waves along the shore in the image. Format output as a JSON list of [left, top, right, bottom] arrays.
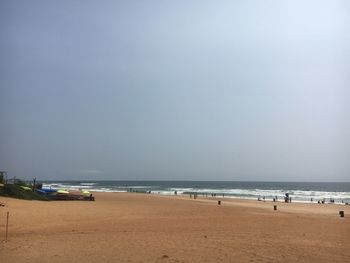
[[42, 181, 350, 204]]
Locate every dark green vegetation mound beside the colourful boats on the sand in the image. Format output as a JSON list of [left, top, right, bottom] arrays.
[[0, 183, 48, 201]]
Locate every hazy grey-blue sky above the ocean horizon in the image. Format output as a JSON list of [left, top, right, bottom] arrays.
[[0, 0, 350, 181]]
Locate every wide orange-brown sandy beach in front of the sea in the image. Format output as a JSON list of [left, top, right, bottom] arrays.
[[0, 193, 350, 262]]
